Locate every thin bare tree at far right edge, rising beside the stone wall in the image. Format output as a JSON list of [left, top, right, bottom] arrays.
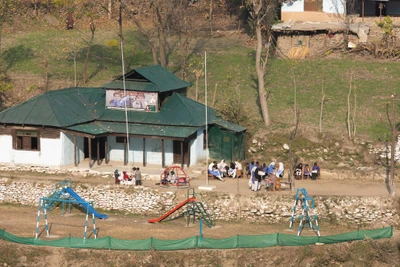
[[386, 94, 399, 197]]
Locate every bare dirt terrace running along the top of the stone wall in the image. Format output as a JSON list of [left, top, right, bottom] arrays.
[[2, 168, 400, 197]]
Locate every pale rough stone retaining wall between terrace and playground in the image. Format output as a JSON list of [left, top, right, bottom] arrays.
[[0, 178, 399, 227]]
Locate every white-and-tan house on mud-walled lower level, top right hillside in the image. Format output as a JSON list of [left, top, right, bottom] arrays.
[[271, 0, 370, 59]]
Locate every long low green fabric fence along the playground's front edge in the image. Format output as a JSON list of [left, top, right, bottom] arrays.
[[0, 226, 393, 250]]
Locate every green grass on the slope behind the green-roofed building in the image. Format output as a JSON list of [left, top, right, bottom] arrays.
[[3, 29, 400, 160]]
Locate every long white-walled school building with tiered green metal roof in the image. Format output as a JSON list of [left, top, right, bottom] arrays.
[[0, 65, 246, 167]]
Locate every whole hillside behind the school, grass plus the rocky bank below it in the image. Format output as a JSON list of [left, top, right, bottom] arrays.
[[1, 6, 400, 174]]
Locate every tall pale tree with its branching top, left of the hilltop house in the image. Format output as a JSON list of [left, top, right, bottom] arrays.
[[246, 0, 279, 127]]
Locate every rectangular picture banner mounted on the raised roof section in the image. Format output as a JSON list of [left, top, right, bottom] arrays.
[[106, 89, 158, 112]]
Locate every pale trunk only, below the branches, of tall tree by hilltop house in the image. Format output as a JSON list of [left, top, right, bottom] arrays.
[[256, 21, 271, 127]]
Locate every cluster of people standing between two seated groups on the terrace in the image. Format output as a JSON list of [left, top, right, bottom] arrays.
[[248, 161, 284, 191]]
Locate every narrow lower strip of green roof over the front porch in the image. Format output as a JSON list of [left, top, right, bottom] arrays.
[[67, 122, 197, 138]]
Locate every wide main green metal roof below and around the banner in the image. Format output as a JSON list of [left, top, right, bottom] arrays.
[[0, 72, 246, 137]]
